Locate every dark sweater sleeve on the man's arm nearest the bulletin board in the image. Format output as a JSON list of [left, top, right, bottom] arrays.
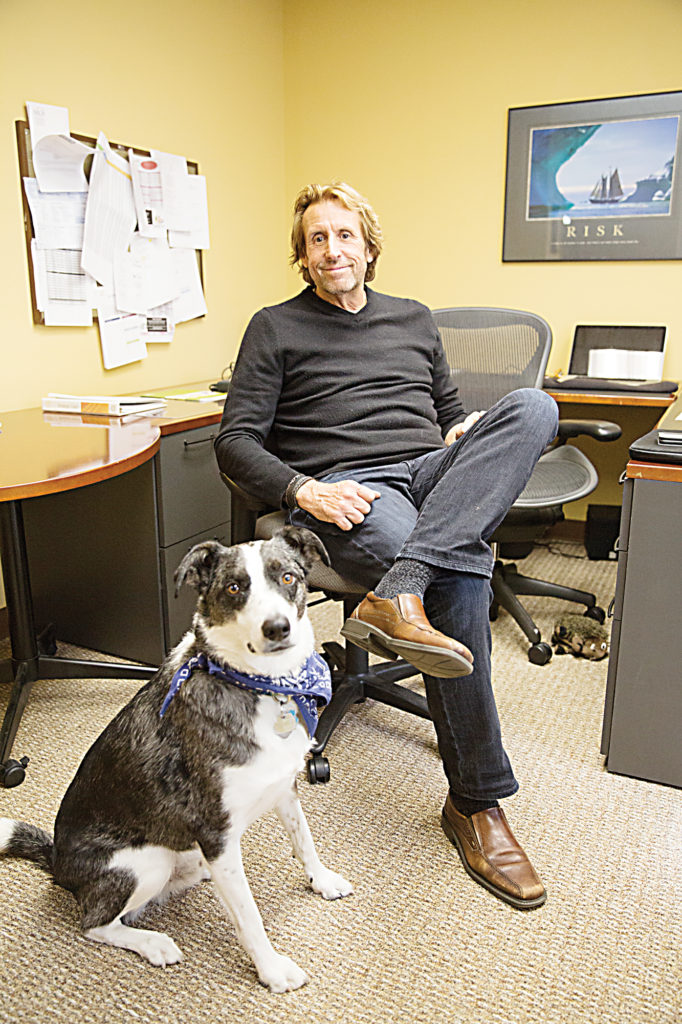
[[215, 309, 296, 508]]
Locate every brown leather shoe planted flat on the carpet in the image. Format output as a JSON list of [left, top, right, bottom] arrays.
[[440, 794, 547, 910]]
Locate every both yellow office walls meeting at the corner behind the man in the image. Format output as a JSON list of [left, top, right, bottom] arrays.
[[0, 0, 682, 614]]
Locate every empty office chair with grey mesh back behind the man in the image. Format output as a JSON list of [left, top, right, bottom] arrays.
[[433, 306, 621, 665]]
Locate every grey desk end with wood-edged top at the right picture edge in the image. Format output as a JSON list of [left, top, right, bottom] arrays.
[[601, 460, 682, 786]]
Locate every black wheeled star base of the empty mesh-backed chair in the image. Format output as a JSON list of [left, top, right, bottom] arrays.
[[491, 561, 603, 665]]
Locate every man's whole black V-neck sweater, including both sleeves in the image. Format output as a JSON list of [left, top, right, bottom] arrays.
[[215, 288, 465, 507]]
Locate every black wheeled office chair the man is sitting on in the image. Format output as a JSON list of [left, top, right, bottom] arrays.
[[221, 473, 431, 783]]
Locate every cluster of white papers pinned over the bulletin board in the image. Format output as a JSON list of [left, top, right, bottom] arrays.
[[24, 102, 209, 370]]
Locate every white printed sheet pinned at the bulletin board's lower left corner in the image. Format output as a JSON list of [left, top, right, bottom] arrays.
[[31, 239, 92, 327]]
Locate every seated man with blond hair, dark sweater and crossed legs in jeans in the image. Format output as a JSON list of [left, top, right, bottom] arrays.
[[216, 183, 557, 909]]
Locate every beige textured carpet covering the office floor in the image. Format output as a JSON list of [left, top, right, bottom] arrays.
[[0, 544, 682, 1024]]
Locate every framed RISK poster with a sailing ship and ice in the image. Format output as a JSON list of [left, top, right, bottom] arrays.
[[502, 92, 682, 262]]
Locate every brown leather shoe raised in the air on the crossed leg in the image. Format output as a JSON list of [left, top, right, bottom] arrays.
[[341, 592, 473, 679]]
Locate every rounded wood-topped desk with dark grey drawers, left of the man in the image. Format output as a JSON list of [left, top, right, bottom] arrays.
[[0, 400, 229, 786]]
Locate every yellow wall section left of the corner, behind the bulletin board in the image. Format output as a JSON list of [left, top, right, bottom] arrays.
[[0, 0, 287, 411]]
